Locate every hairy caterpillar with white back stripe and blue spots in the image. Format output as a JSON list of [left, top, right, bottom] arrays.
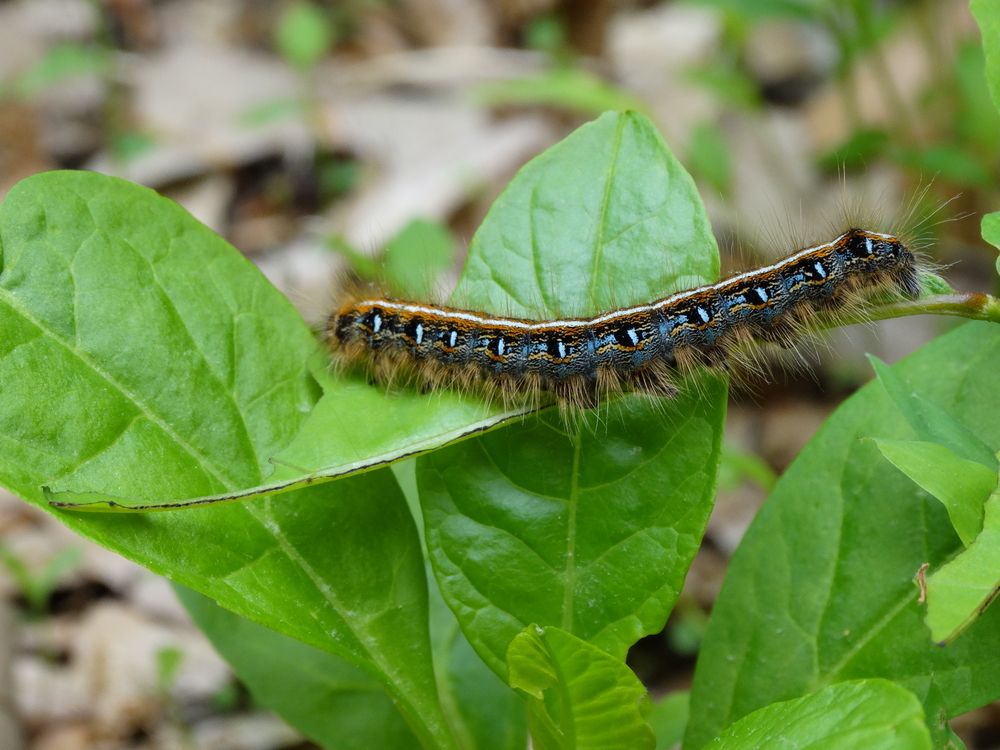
[[327, 229, 920, 408]]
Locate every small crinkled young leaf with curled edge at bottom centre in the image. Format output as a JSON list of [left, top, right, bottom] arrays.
[[507, 625, 656, 750]]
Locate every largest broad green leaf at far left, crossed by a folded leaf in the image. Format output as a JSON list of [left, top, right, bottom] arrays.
[[0, 172, 451, 748]]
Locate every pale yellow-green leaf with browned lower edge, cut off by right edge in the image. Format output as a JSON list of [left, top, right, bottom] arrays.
[[924, 476, 1000, 645]]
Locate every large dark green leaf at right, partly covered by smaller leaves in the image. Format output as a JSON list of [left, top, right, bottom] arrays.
[[685, 323, 1000, 750]]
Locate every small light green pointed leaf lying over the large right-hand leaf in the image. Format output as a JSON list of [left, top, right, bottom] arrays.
[[872, 438, 997, 547]]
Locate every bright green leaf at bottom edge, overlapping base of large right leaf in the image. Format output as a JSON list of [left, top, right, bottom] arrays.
[[705, 680, 932, 750]]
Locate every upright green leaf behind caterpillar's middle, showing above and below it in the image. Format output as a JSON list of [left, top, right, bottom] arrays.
[[417, 113, 726, 676]]
